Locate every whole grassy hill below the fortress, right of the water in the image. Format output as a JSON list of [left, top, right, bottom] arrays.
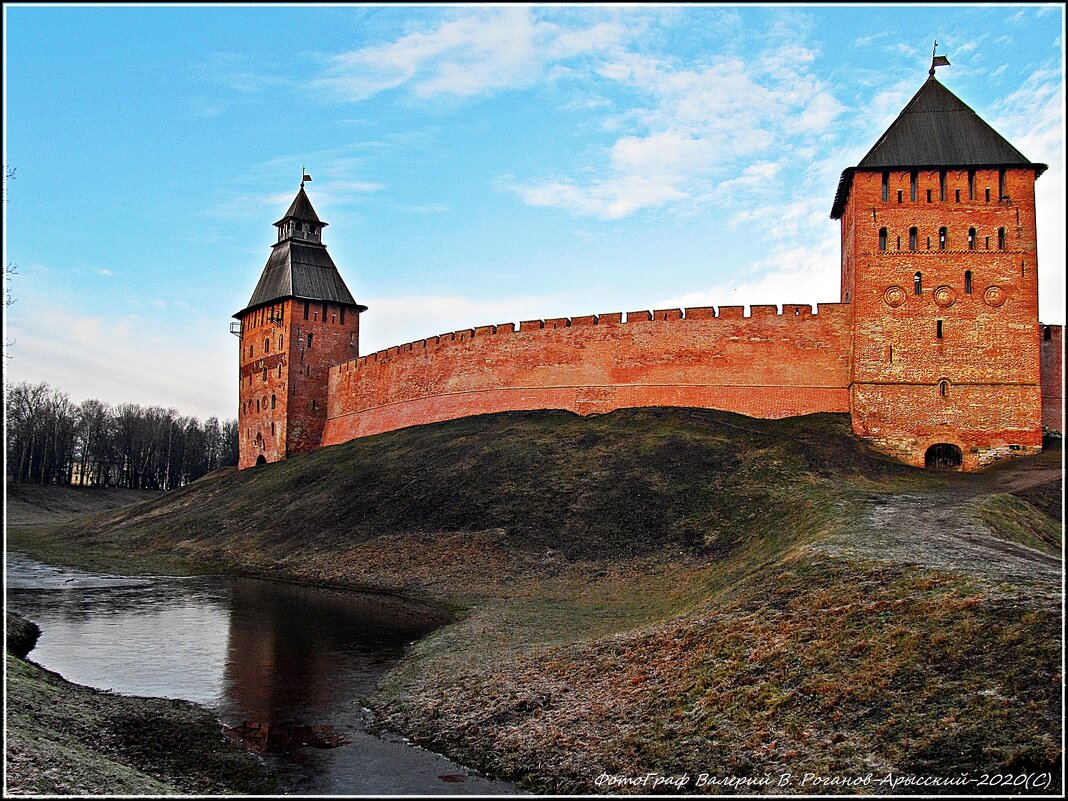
[[9, 409, 1062, 792]]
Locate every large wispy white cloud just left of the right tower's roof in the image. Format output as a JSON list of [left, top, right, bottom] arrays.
[[511, 26, 845, 220]]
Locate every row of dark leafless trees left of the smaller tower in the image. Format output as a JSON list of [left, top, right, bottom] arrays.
[[5, 381, 237, 489]]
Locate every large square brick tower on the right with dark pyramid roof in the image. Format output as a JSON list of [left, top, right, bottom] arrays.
[[831, 68, 1046, 470]]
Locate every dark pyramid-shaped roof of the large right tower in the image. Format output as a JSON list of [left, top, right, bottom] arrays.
[[831, 76, 1046, 220]]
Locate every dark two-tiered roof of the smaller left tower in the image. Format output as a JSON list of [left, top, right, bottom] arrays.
[[234, 185, 366, 317]]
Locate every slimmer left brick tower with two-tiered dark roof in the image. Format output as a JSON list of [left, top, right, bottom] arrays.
[[231, 182, 366, 468]]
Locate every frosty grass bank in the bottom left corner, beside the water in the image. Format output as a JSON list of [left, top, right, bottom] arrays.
[[5, 612, 277, 796]]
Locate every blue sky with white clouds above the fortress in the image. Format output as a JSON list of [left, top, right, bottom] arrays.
[[3, 3, 1065, 418]]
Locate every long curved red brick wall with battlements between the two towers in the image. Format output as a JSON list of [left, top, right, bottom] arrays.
[[323, 303, 850, 444]]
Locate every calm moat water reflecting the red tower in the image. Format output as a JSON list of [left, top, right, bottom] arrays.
[[5, 553, 519, 796]]
